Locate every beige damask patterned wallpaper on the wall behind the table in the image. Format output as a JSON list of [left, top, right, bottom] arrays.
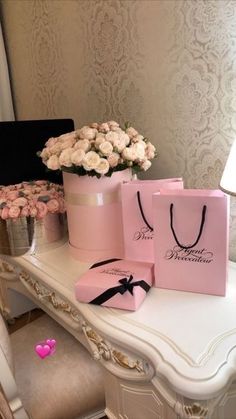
[[1, 0, 236, 260]]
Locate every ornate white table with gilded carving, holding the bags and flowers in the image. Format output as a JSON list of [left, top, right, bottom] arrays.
[[0, 244, 236, 419]]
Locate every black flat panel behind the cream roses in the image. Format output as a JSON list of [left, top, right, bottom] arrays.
[[0, 119, 74, 185]]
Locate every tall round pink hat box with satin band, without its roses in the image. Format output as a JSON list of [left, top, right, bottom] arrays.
[[63, 169, 131, 262]]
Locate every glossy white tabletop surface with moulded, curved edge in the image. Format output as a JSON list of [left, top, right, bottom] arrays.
[[12, 244, 236, 398]]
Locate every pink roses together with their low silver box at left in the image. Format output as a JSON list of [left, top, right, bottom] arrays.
[[0, 180, 66, 256]]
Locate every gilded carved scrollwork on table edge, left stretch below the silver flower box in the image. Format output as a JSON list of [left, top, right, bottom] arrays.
[[19, 271, 82, 324]]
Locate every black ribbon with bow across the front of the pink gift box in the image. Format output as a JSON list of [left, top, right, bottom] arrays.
[[90, 275, 151, 305]]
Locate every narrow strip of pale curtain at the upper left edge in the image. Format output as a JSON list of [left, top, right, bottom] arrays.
[[0, 22, 15, 121]]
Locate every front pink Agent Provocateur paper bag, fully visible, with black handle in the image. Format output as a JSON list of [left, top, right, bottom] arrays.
[[153, 189, 229, 295]]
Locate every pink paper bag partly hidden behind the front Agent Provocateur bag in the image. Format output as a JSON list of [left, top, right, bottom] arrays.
[[121, 178, 183, 263]]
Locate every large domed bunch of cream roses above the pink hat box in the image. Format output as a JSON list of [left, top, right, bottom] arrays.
[[38, 121, 156, 178]]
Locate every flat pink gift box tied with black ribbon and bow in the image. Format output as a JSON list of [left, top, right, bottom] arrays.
[[75, 260, 154, 310]]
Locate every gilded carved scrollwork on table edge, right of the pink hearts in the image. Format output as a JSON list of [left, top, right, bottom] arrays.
[[82, 323, 145, 373]]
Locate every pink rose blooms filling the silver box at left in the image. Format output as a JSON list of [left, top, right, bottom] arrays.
[[0, 180, 65, 220]]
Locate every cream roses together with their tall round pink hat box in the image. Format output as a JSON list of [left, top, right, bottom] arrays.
[[38, 121, 156, 262]]
